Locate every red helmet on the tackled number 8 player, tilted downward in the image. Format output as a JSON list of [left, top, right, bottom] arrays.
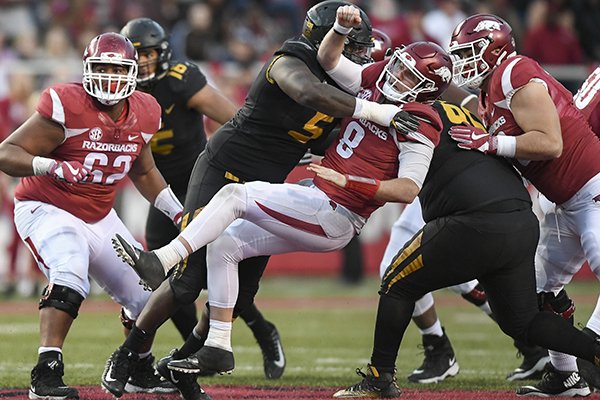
[[376, 42, 452, 103]]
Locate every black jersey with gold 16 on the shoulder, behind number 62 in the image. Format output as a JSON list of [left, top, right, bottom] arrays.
[[150, 61, 206, 192]]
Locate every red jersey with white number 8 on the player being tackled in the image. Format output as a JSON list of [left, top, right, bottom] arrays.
[[314, 61, 441, 218]]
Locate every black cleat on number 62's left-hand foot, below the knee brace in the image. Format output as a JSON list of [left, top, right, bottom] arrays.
[[29, 359, 79, 400]]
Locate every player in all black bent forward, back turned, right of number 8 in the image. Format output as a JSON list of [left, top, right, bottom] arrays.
[[330, 7, 600, 398]]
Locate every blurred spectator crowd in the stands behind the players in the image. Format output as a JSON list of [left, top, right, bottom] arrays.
[[0, 0, 600, 294]]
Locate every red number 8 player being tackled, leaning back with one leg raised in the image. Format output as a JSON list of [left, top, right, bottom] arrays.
[[112, 36, 452, 382]]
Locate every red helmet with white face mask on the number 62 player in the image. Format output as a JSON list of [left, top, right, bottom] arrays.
[[83, 33, 137, 106]]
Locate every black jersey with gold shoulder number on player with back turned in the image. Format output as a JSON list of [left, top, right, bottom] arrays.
[[419, 101, 531, 222]]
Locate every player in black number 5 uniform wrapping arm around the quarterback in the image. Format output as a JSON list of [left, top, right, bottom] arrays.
[[105, 1, 418, 393]]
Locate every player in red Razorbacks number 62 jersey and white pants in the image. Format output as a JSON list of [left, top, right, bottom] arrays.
[[0, 33, 182, 399]]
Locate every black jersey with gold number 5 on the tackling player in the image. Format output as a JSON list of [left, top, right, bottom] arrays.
[[207, 36, 339, 182]]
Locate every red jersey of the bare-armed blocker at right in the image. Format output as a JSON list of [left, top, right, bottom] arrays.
[[479, 55, 600, 204]]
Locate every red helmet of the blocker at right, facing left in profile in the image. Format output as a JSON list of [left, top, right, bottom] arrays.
[[449, 14, 515, 88]]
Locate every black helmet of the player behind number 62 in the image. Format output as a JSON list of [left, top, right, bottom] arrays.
[[121, 18, 171, 86]]
